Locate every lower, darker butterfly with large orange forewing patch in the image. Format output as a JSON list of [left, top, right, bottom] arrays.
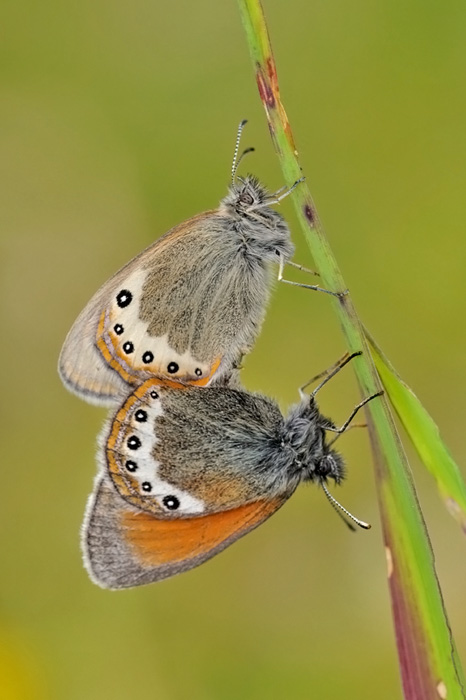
[[82, 356, 373, 589]]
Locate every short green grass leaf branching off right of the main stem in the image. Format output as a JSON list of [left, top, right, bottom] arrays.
[[366, 334, 466, 533]]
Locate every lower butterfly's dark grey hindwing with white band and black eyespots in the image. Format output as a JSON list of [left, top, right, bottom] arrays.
[[100, 378, 297, 518]]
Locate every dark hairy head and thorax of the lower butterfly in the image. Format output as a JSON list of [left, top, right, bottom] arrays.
[[283, 396, 345, 484]]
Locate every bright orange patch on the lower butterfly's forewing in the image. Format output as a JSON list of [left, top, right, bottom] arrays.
[[121, 496, 287, 566]]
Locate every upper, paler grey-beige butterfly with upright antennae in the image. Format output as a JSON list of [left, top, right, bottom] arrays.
[[59, 121, 316, 406]]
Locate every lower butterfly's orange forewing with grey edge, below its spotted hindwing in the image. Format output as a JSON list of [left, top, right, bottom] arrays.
[[82, 476, 288, 589]]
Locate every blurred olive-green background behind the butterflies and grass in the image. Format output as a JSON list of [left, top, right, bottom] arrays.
[[0, 0, 466, 700]]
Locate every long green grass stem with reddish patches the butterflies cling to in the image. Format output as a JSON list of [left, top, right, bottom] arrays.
[[238, 0, 465, 700]]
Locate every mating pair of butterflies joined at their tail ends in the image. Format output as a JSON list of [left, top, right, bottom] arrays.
[[59, 122, 372, 588]]
